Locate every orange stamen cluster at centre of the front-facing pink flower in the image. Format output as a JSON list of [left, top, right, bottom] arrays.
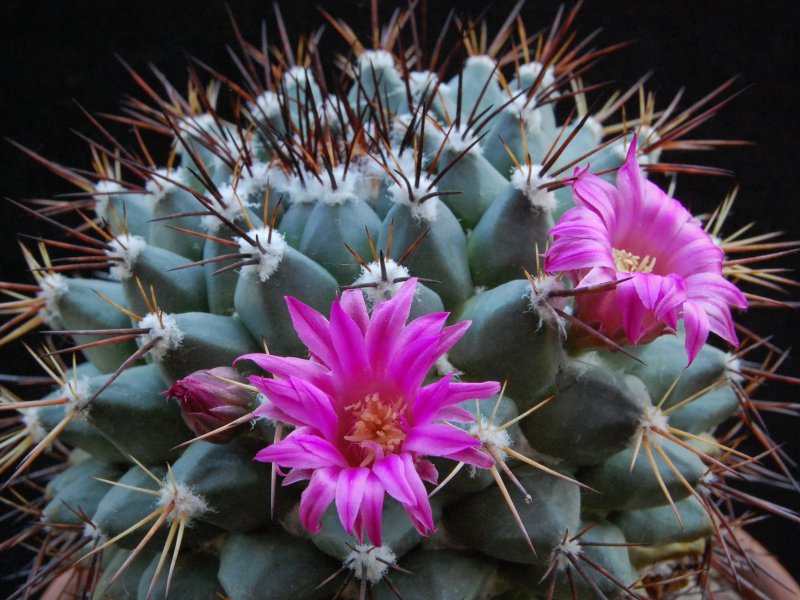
[[344, 392, 406, 467]]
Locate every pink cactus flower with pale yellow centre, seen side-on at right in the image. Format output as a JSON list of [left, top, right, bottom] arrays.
[[545, 138, 747, 363]]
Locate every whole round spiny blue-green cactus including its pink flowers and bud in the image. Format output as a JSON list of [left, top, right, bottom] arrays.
[[0, 3, 798, 600]]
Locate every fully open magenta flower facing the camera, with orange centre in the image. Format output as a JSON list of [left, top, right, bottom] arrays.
[[239, 279, 500, 546]]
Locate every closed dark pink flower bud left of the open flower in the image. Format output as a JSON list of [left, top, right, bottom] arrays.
[[164, 367, 255, 444]]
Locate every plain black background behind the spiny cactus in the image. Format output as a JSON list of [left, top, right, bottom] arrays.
[[0, 0, 800, 592]]
